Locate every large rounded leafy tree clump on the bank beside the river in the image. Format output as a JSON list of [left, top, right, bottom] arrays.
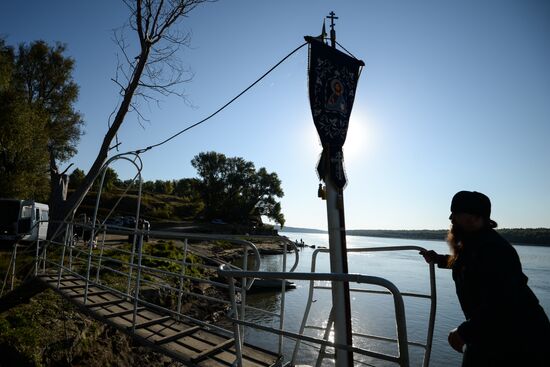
[[191, 152, 285, 226]]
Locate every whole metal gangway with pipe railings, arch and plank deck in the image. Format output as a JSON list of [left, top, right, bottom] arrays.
[[0, 154, 436, 367]]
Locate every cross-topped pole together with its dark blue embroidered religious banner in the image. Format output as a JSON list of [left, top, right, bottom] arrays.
[[305, 12, 365, 367]]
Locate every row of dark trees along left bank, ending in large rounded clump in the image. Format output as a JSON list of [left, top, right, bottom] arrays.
[[69, 151, 285, 227]]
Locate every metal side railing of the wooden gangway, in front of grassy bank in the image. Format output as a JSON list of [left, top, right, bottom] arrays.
[[35, 222, 274, 342]]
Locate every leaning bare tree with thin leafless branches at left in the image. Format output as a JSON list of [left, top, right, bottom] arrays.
[[50, 0, 209, 234]]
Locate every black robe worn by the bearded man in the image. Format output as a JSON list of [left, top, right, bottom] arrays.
[[438, 229, 550, 366]]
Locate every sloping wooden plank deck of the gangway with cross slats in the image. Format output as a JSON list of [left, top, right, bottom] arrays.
[[37, 274, 281, 367]]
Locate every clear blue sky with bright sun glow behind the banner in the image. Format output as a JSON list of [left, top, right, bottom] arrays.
[[0, 0, 550, 229]]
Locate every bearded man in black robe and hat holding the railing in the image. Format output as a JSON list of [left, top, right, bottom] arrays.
[[421, 191, 550, 367]]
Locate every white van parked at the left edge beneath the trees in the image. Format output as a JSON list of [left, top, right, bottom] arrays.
[[0, 199, 49, 243]]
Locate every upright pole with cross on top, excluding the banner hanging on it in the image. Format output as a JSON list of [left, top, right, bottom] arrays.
[[325, 11, 353, 367]]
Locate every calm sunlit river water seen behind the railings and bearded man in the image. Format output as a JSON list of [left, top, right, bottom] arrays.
[[245, 232, 550, 366]]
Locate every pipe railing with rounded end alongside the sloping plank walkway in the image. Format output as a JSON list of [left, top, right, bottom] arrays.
[[35, 223, 272, 334]]
